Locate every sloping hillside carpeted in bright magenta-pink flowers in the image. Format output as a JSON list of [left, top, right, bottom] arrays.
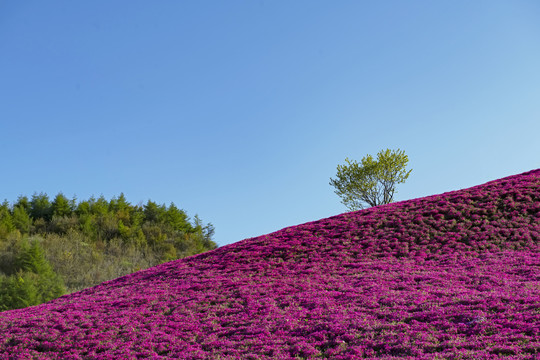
[[0, 170, 540, 359]]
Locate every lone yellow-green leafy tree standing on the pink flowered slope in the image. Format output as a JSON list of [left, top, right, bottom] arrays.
[[330, 149, 412, 211]]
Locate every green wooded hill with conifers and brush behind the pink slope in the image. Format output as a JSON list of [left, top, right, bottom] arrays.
[[0, 193, 217, 311]]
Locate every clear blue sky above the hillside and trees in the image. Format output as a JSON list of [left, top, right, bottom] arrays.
[[0, 0, 540, 245]]
